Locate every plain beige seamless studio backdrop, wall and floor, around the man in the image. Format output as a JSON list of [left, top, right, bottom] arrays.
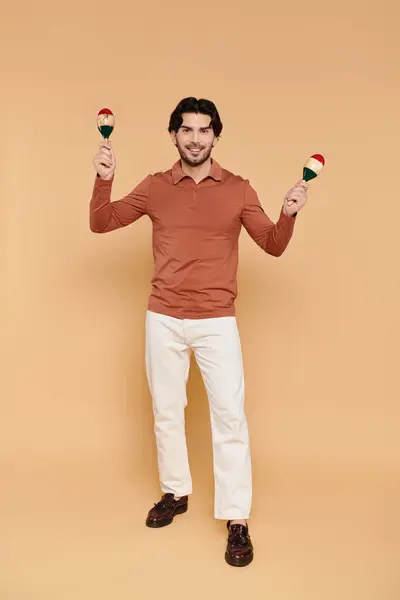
[[0, 0, 400, 600]]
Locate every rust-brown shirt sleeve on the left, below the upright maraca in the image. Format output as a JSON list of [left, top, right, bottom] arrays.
[[89, 175, 151, 233]]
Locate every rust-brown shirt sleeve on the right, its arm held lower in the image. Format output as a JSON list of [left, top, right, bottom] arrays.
[[242, 180, 296, 256]]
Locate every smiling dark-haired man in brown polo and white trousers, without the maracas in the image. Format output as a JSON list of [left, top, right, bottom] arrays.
[[90, 98, 307, 566]]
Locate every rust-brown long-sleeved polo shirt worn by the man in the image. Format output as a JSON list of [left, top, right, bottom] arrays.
[[90, 160, 296, 319]]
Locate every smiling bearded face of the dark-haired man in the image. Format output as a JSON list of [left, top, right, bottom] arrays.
[[171, 113, 215, 167]]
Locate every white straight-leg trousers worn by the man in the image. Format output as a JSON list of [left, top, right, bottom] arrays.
[[146, 311, 252, 520]]
